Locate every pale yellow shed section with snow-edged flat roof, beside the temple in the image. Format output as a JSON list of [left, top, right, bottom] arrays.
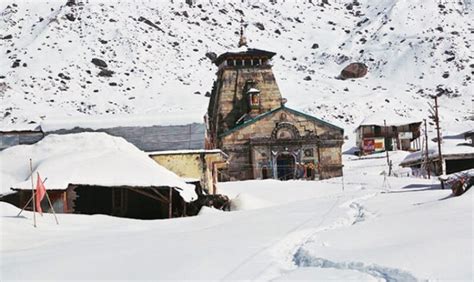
[[148, 149, 228, 194]]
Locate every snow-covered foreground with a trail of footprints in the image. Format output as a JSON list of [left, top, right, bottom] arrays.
[[0, 152, 473, 281]]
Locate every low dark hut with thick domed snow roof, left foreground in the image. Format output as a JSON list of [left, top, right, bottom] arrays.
[[0, 132, 197, 219]]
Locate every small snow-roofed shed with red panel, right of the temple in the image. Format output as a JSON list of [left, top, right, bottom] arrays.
[[355, 113, 422, 154]]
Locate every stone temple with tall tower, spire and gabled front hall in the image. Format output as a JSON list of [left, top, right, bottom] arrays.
[[205, 31, 344, 181]]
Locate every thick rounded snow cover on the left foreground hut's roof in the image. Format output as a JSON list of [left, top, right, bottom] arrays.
[[0, 132, 196, 201]]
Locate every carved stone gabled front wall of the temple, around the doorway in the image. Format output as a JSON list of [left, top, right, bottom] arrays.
[[219, 107, 342, 180]]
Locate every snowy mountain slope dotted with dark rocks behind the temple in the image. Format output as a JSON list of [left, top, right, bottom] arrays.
[[0, 0, 474, 133]]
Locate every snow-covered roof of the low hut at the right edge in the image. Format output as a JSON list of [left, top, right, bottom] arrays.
[[400, 138, 474, 166]]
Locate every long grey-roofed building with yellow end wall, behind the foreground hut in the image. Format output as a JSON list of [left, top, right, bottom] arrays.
[[2, 113, 227, 193]]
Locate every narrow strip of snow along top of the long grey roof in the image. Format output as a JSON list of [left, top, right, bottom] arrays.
[[41, 113, 202, 132]]
